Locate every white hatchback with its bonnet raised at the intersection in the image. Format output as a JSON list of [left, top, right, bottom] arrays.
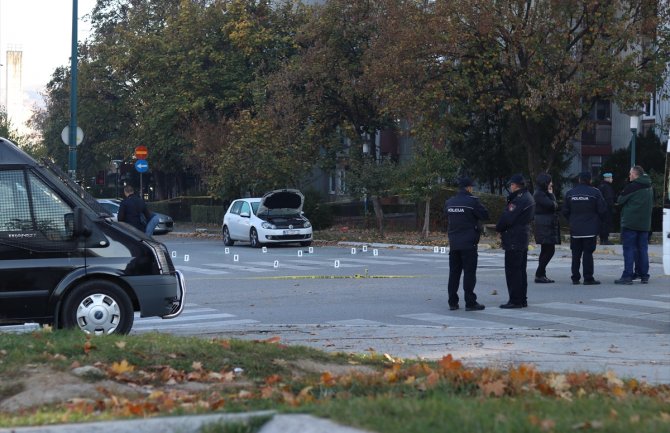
[[221, 189, 312, 248]]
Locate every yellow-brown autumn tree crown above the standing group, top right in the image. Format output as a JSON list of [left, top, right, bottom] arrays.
[[444, 0, 669, 182]]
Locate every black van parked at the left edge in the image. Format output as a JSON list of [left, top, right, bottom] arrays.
[[0, 138, 185, 334]]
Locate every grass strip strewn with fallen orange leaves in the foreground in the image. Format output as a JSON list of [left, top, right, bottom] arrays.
[[0, 331, 670, 433]]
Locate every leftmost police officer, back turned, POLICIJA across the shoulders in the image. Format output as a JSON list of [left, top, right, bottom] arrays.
[[444, 177, 489, 311]]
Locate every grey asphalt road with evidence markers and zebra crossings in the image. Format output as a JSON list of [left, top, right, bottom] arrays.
[[133, 237, 670, 335]]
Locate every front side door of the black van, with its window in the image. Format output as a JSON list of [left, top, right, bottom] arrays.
[[0, 168, 85, 324]]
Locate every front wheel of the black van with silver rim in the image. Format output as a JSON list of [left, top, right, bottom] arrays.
[[62, 280, 135, 335]]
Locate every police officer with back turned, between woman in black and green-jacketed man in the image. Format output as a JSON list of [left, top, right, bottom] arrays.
[[562, 171, 607, 285]]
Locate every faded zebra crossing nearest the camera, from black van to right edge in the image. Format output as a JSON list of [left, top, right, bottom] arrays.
[[133, 294, 670, 334]]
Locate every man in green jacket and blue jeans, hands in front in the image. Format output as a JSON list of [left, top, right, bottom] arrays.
[[614, 165, 654, 284]]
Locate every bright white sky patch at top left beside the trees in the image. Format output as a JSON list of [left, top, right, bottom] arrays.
[[0, 0, 96, 130]]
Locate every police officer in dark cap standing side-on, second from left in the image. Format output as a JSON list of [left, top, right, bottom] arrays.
[[496, 174, 535, 308]]
